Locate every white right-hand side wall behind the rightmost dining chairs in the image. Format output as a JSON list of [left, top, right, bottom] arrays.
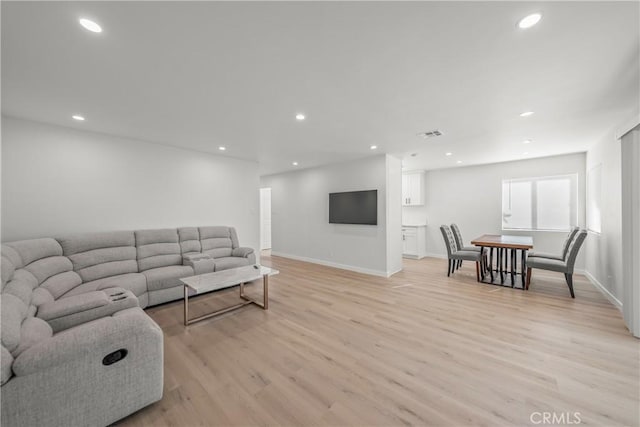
[[585, 134, 623, 306]]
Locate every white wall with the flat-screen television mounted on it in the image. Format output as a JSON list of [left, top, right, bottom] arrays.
[[261, 155, 401, 276]]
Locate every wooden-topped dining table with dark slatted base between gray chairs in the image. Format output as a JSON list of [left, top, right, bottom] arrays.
[[471, 234, 533, 290]]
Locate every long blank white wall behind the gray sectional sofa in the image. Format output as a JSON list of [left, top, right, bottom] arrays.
[[2, 117, 260, 254]]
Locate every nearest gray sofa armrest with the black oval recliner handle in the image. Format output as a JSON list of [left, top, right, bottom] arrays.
[[0, 307, 163, 426]]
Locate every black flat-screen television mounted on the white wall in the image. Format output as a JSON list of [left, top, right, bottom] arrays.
[[329, 190, 378, 225]]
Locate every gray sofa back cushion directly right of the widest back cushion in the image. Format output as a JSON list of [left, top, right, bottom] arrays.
[[135, 228, 182, 272]]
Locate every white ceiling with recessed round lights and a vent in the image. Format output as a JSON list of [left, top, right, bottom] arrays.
[[1, 1, 640, 174]]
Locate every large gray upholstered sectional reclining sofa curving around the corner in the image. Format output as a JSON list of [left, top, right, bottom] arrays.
[[0, 227, 255, 426]]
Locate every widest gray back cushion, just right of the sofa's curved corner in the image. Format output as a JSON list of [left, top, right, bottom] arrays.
[[57, 231, 138, 283]]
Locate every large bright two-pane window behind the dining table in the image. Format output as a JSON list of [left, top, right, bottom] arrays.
[[502, 174, 578, 231]]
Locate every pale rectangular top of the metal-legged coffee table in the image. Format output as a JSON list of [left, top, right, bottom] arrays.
[[180, 265, 279, 294]]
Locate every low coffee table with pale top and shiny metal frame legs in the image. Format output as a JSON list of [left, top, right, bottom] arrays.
[[180, 265, 279, 326]]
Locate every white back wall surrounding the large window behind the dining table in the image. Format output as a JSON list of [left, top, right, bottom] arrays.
[[402, 153, 585, 270]]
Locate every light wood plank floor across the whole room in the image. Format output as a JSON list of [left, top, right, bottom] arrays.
[[119, 256, 640, 426]]
